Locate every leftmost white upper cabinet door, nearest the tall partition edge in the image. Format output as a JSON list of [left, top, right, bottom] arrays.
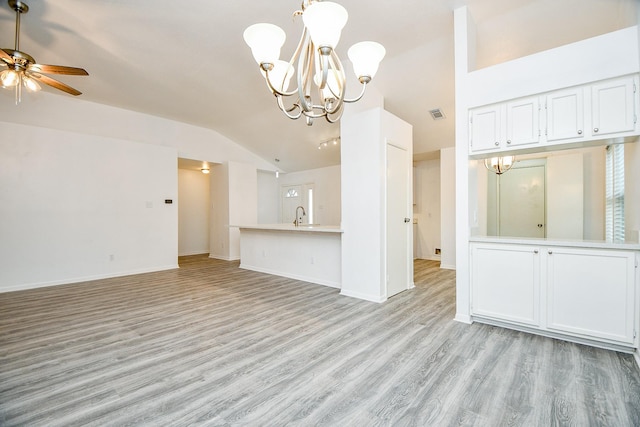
[[469, 105, 502, 152]]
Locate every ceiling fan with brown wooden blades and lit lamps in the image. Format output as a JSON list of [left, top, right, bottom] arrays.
[[0, 0, 89, 104]]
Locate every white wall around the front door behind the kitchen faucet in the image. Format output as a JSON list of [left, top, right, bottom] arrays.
[[276, 165, 341, 225]]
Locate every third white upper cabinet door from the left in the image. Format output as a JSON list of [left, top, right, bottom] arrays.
[[545, 87, 584, 141]]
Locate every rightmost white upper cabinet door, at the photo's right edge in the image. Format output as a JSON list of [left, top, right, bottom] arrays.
[[591, 76, 636, 136]]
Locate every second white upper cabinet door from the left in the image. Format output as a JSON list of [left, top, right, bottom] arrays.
[[506, 96, 540, 146]]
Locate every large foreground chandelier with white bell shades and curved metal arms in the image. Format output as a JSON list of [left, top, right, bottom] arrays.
[[244, 0, 385, 126]]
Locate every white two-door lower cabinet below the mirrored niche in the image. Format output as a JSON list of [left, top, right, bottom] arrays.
[[471, 242, 637, 347]]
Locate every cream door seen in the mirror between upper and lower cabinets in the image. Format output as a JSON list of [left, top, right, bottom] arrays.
[[498, 165, 546, 237]]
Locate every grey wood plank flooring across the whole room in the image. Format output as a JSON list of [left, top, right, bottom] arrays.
[[0, 256, 640, 426]]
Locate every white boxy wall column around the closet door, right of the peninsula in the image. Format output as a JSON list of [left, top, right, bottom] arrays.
[[340, 108, 413, 302]]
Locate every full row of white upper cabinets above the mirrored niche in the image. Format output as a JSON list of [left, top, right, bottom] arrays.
[[469, 75, 640, 155]]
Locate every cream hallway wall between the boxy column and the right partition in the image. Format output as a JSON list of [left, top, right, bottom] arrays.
[[413, 159, 442, 261]]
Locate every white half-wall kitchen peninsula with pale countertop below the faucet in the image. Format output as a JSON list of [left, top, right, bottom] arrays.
[[234, 224, 342, 289]]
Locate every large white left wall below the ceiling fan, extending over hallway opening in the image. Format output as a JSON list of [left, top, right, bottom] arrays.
[[0, 92, 275, 291]]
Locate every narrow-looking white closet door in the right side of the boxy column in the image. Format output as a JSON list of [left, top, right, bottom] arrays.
[[387, 144, 412, 297]]
